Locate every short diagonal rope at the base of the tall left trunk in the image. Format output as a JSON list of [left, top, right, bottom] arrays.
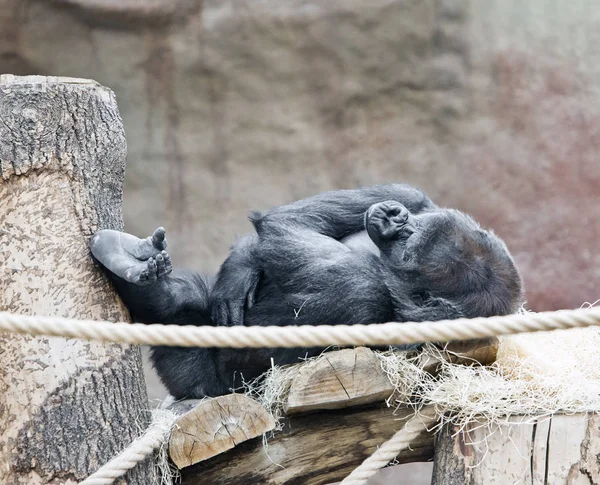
[[79, 411, 177, 485]]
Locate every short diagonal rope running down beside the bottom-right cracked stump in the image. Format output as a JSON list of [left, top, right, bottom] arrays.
[[340, 406, 438, 485]]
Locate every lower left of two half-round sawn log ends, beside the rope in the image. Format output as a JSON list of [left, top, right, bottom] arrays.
[[169, 394, 275, 468]]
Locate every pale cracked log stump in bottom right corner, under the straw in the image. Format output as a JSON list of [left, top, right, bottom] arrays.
[[431, 414, 600, 485]]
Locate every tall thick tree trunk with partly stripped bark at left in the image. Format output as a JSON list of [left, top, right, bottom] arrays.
[[0, 75, 154, 485]]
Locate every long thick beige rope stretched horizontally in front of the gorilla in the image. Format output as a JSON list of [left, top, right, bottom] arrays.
[[0, 307, 600, 348]]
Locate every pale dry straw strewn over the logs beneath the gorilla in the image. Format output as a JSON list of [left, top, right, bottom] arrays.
[[245, 306, 600, 438]]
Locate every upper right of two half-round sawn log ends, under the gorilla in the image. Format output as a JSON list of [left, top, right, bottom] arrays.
[[285, 347, 394, 415]]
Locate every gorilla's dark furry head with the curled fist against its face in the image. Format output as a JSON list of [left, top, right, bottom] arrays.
[[365, 201, 523, 317]]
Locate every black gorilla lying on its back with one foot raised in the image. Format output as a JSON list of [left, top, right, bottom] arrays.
[[90, 184, 522, 398]]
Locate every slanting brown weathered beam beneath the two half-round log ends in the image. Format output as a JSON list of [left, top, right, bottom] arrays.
[[181, 405, 433, 485]]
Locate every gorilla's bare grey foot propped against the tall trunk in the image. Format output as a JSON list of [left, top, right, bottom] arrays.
[[90, 227, 173, 285]]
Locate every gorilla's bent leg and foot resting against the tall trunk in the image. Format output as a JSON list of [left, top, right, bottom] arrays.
[[90, 228, 230, 399]]
